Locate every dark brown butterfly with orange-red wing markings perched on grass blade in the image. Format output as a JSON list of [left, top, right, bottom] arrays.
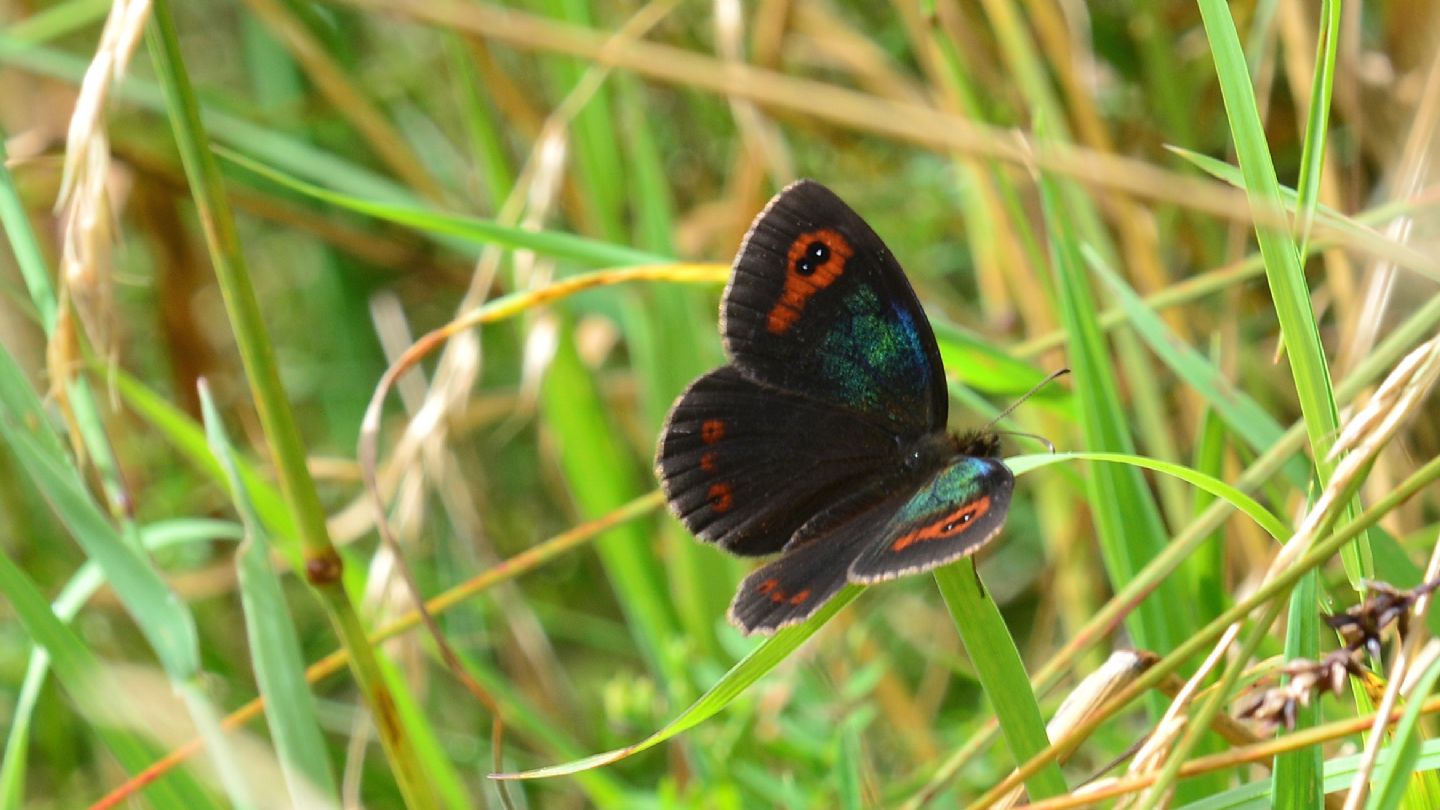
[[655, 180, 1015, 634]]
